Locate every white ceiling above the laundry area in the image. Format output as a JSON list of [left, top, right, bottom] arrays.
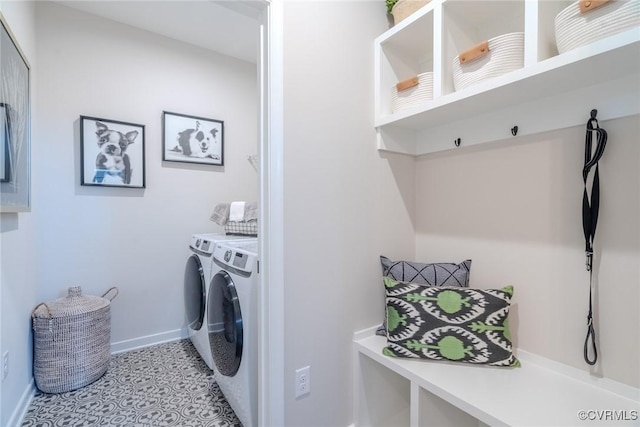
[[54, 0, 264, 63]]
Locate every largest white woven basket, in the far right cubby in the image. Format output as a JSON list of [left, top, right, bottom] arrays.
[[555, 0, 640, 53]]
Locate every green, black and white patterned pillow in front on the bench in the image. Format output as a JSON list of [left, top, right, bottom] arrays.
[[382, 277, 520, 366]]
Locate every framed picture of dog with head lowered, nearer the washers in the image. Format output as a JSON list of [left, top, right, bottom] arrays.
[[162, 111, 224, 166]]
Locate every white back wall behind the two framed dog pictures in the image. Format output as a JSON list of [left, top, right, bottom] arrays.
[[34, 3, 258, 342]]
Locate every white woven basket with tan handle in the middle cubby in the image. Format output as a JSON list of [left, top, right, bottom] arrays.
[[453, 32, 524, 90]]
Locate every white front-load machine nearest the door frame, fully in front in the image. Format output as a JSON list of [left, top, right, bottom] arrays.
[[207, 239, 259, 427]]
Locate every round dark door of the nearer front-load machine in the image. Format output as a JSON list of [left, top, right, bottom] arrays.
[[207, 270, 243, 377]]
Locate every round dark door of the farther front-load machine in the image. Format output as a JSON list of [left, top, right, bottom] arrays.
[[184, 254, 207, 331]]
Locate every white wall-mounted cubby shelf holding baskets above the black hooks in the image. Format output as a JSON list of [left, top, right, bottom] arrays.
[[375, 0, 640, 155]]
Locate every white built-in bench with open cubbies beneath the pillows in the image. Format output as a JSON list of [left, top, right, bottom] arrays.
[[353, 327, 640, 427]]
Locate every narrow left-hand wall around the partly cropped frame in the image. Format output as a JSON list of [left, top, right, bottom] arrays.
[[0, 1, 37, 426]]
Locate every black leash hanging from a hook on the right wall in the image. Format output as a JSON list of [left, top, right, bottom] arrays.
[[582, 110, 607, 365]]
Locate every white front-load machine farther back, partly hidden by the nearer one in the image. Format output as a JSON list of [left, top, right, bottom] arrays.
[[184, 233, 255, 370]]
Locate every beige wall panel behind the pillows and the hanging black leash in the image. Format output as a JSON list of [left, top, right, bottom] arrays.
[[416, 116, 640, 387]]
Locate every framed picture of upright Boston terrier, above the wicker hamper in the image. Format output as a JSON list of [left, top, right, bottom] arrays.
[[80, 116, 144, 188]]
